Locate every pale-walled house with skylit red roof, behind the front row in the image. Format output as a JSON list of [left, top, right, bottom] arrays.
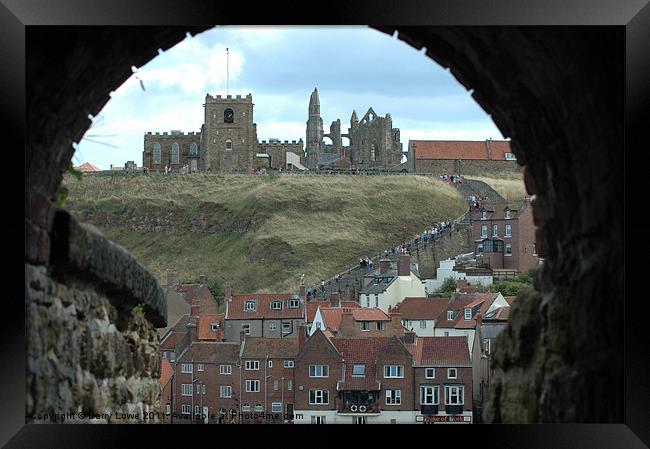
[[224, 293, 306, 343]]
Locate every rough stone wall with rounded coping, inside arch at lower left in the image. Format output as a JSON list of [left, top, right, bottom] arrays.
[[25, 209, 167, 423]]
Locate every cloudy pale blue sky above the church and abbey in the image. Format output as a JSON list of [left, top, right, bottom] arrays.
[[73, 26, 503, 169]]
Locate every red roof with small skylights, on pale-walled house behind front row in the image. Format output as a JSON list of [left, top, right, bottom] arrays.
[[226, 293, 305, 320]]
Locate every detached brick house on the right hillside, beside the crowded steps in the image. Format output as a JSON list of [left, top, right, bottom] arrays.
[[470, 199, 539, 275]]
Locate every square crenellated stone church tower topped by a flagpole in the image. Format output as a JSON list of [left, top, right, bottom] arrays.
[[201, 94, 257, 173]]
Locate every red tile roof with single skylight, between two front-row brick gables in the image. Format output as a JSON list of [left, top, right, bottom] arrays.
[[331, 337, 410, 391]]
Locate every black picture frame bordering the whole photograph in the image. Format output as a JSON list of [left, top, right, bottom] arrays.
[[8, 0, 650, 448]]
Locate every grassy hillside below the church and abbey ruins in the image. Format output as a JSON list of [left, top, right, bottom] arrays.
[[64, 174, 466, 292]]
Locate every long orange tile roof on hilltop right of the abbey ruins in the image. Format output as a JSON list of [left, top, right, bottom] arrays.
[[411, 140, 512, 161]]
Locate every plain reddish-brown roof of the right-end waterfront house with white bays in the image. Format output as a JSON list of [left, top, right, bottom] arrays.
[[409, 335, 471, 367]]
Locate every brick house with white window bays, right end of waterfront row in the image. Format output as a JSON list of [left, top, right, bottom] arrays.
[[408, 336, 473, 424]]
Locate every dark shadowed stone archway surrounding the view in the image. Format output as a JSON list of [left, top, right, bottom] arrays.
[[25, 27, 624, 422]]
